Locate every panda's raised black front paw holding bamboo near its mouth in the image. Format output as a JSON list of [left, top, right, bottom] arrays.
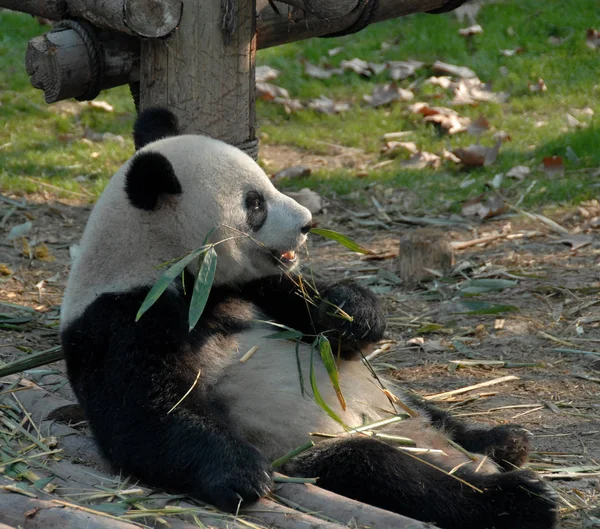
[[318, 283, 386, 352]]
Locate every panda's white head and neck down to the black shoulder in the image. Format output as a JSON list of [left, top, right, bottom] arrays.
[[63, 109, 311, 320]]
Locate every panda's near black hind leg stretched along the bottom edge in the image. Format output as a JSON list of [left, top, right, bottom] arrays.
[[284, 437, 556, 529]]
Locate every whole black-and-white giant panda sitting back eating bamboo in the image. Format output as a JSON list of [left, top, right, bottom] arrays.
[[60, 109, 556, 529]]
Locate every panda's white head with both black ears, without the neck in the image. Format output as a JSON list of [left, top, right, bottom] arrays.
[[124, 109, 311, 284]]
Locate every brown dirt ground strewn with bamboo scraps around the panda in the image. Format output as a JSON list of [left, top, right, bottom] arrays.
[[0, 176, 600, 528]]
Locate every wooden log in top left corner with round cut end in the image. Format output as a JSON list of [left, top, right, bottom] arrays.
[[0, 0, 182, 37]]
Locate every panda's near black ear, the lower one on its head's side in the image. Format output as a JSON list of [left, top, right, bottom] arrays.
[[125, 152, 181, 211]]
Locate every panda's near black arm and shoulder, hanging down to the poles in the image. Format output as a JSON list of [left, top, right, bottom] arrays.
[[61, 289, 271, 510]]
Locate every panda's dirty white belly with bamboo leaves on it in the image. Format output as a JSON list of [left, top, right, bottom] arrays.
[[215, 327, 394, 459]]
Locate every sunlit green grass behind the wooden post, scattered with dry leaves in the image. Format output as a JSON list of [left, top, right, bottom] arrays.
[[0, 4, 600, 210]]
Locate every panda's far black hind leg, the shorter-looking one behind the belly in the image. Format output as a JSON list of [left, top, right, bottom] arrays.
[[402, 393, 533, 470]]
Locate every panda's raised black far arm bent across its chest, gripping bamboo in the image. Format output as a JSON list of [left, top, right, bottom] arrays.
[[241, 275, 386, 354]]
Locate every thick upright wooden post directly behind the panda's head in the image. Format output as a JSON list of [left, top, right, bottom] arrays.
[[140, 0, 258, 153]]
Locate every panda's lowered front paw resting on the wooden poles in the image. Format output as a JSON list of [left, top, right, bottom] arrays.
[[205, 447, 273, 512]]
